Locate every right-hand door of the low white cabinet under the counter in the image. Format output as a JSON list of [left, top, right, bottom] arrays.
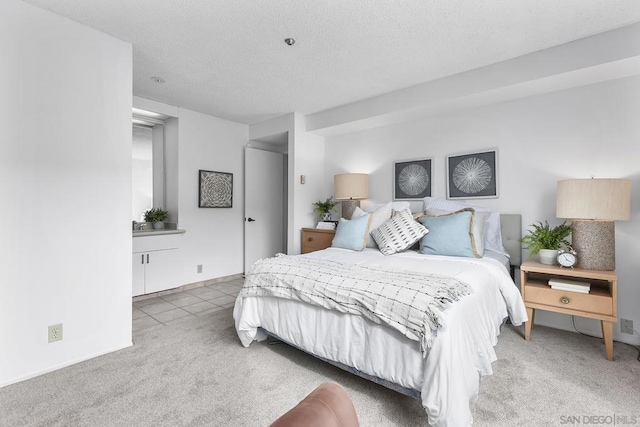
[[144, 249, 182, 294]]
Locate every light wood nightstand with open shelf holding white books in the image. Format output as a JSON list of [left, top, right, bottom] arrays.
[[520, 260, 618, 360]]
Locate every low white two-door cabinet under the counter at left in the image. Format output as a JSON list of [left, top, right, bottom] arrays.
[[133, 235, 182, 297]]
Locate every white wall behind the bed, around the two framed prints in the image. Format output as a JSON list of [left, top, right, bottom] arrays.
[[325, 76, 640, 343]]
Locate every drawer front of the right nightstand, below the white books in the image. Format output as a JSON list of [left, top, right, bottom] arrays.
[[525, 284, 613, 316]]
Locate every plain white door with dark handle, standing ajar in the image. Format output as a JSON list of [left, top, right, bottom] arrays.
[[244, 147, 285, 273]]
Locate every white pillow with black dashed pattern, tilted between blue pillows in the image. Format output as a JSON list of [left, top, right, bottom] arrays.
[[371, 210, 429, 255]]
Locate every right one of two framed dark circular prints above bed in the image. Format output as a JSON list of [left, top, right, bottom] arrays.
[[446, 150, 498, 199]]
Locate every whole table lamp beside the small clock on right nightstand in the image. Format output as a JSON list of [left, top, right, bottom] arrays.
[[556, 178, 631, 271]]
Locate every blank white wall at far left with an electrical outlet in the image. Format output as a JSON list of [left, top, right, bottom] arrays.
[[0, 0, 132, 386]]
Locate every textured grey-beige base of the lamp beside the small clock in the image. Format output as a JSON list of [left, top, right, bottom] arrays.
[[571, 220, 616, 271]]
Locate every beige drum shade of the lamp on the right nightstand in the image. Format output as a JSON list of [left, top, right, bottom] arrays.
[[556, 179, 631, 221]]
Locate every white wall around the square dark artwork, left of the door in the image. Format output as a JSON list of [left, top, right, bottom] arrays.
[[178, 108, 249, 283]]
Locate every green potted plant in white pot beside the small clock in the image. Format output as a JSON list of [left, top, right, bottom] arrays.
[[520, 221, 571, 265]]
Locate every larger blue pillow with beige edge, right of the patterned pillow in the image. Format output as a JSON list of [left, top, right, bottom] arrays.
[[418, 211, 475, 258]]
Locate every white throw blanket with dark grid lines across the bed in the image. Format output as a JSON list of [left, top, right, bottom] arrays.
[[240, 255, 471, 356]]
